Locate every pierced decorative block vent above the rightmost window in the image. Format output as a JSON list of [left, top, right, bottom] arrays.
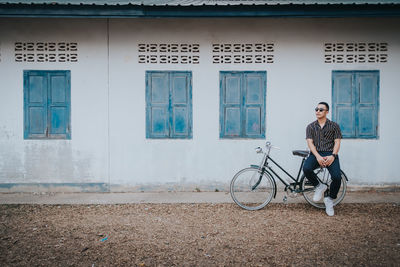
[[324, 43, 388, 63]]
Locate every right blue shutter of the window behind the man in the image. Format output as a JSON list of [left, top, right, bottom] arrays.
[[355, 72, 379, 138]]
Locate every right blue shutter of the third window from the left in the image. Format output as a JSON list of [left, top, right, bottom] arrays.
[[242, 72, 265, 137]]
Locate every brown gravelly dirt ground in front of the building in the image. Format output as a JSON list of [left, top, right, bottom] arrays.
[[0, 204, 400, 266]]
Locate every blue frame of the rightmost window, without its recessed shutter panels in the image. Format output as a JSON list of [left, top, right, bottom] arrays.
[[332, 70, 380, 139]]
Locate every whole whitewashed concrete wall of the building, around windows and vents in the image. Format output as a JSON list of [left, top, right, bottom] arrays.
[[0, 18, 400, 191]]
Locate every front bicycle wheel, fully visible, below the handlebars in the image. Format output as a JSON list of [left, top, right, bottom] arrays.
[[230, 167, 276, 210]]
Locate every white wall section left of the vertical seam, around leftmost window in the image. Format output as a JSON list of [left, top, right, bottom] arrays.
[[0, 19, 108, 191]]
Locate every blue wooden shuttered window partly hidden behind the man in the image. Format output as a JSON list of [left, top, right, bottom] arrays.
[[332, 71, 379, 138]]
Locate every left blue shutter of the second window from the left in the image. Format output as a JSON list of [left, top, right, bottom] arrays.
[[146, 72, 170, 138]]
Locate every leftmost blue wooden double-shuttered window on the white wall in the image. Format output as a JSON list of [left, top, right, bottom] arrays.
[[24, 70, 71, 139]]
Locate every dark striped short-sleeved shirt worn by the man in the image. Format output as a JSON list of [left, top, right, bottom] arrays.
[[306, 119, 342, 151]]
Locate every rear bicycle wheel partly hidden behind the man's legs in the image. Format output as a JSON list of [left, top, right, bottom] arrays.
[[300, 169, 347, 209]]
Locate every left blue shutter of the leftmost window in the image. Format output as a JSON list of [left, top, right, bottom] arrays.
[[24, 71, 47, 139]]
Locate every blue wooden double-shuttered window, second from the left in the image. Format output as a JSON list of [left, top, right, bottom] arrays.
[[146, 71, 192, 139]]
